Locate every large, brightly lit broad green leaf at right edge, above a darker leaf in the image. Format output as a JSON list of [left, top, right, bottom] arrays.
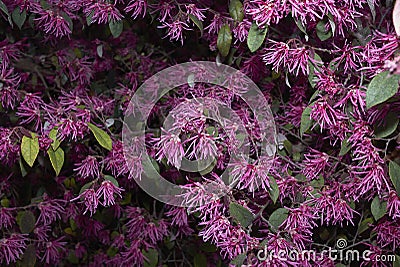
[[366, 71, 400, 109]]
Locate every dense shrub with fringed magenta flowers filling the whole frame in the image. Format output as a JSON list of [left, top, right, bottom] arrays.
[[0, 0, 400, 266]]
